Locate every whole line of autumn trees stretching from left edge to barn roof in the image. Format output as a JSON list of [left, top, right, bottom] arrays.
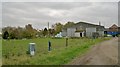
[[2, 22, 75, 39]]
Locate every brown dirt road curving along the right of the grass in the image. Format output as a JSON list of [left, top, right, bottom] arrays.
[[69, 37, 118, 65]]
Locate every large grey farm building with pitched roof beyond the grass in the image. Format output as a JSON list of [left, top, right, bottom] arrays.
[[62, 22, 105, 37]]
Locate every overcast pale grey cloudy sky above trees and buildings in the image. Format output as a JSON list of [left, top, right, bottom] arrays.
[[0, 0, 118, 29]]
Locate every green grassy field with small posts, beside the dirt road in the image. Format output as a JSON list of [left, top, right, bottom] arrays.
[[2, 38, 109, 65]]
